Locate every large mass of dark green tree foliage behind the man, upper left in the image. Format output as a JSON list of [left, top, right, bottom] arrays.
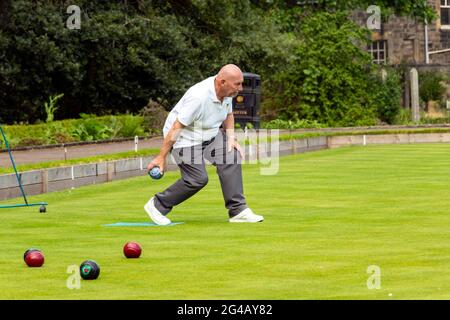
[[0, 0, 291, 122]]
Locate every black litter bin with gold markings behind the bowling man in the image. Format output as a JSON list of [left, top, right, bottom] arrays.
[[233, 72, 261, 129]]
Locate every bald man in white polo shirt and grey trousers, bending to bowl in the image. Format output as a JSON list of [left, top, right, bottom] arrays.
[[144, 64, 264, 225]]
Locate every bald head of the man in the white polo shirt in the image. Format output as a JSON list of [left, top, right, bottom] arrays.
[[215, 64, 244, 101]]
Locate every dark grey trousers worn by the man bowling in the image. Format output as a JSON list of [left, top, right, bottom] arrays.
[[155, 131, 247, 217]]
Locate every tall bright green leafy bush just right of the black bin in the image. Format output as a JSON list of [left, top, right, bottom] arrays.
[[263, 12, 377, 126]]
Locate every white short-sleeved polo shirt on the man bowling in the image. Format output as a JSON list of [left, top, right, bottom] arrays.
[[163, 76, 233, 148]]
